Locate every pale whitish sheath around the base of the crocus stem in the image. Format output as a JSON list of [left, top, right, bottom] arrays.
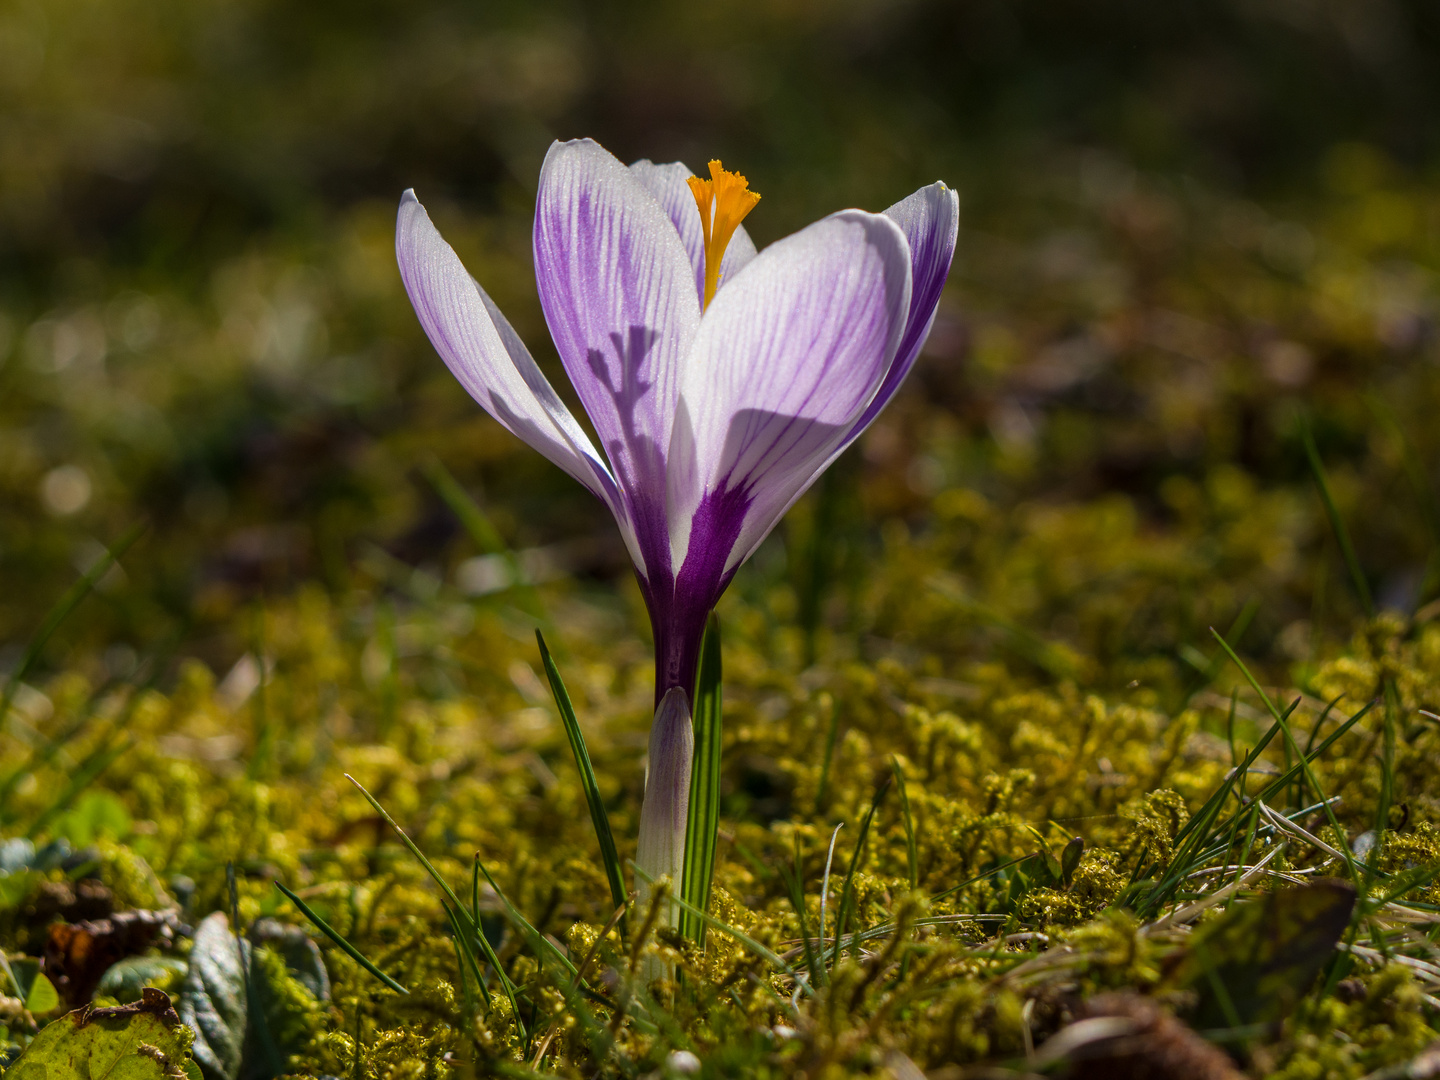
[[635, 687, 696, 926]]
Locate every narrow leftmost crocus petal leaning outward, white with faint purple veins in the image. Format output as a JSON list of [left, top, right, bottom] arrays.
[[395, 192, 634, 567]]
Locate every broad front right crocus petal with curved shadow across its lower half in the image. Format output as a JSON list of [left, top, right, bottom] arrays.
[[668, 210, 910, 602]]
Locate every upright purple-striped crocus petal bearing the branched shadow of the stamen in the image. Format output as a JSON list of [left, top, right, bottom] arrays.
[[534, 140, 700, 582]]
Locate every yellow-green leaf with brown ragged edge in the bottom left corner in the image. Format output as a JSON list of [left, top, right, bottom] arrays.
[[6, 989, 193, 1080]]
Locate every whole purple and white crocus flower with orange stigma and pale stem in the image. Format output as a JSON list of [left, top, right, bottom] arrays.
[[396, 140, 959, 910]]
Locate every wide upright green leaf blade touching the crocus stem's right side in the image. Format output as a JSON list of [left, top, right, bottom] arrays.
[[680, 612, 721, 946]]
